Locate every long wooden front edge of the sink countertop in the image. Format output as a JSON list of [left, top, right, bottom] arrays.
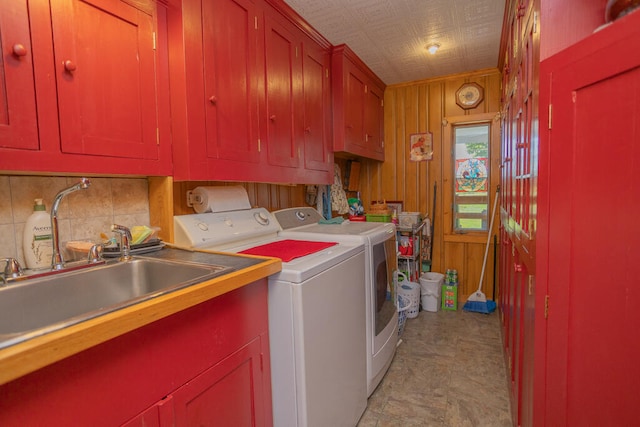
[[0, 251, 282, 385]]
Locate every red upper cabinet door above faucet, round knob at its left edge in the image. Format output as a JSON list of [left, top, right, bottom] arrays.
[[51, 0, 159, 159]]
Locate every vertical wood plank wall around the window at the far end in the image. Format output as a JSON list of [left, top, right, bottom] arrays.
[[360, 69, 502, 301]]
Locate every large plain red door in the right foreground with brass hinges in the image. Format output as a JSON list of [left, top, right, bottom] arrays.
[[537, 13, 640, 425]]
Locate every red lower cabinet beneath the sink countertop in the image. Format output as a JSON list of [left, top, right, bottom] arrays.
[[0, 280, 273, 427]]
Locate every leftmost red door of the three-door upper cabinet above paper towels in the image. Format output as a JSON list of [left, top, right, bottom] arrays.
[[202, 0, 260, 163]]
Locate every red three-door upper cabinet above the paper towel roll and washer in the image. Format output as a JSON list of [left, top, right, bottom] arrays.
[[169, 0, 333, 184]]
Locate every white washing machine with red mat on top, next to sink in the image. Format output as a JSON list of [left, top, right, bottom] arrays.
[[174, 190, 367, 427]]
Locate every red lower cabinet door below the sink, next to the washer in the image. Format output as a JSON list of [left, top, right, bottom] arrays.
[[160, 337, 271, 426]]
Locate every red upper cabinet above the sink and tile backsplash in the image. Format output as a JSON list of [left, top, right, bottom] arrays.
[[0, 0, 171, 175]]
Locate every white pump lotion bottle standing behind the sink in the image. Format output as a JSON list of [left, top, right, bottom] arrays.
[[22, 199, 53, 269]]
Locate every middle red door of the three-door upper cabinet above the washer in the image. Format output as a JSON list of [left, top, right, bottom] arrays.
[[264, 13, 303, 167]]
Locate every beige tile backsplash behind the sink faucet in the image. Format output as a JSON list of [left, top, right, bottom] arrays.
[[0, 175, 149, 268]]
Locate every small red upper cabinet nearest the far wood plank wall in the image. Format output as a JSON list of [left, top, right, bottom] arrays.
[[332, 45, 386, 161]]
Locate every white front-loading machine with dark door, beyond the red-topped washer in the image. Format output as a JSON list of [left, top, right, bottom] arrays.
[[273, 207, 398, 396]]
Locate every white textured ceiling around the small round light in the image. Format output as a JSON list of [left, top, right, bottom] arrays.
[[284, 0, 505, 85]]
